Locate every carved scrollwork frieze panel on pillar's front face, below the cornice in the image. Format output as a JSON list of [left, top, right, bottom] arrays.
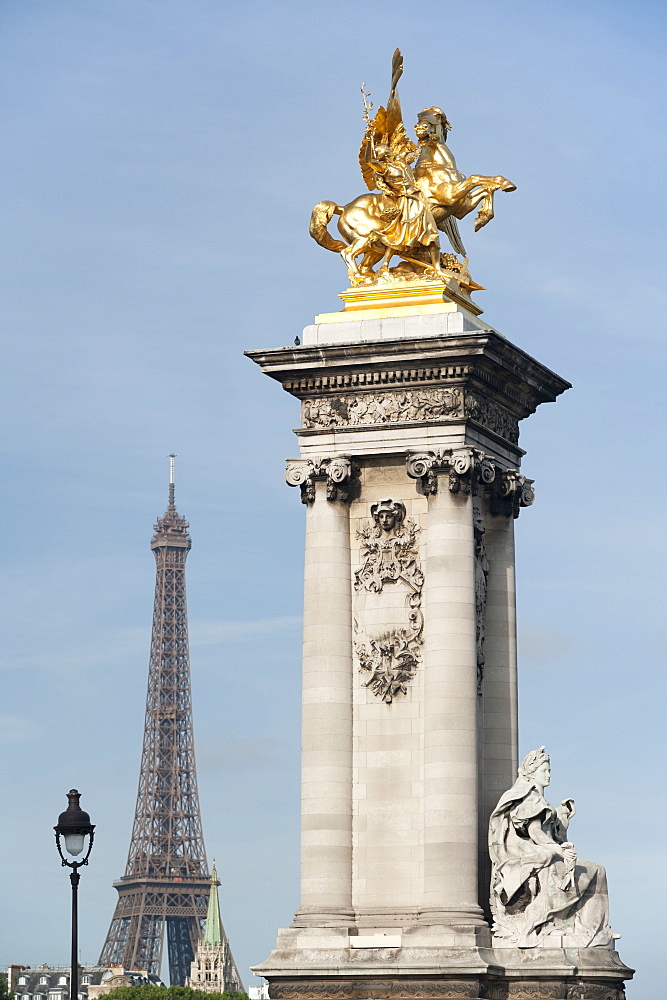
[[302, 387, 463, 428]]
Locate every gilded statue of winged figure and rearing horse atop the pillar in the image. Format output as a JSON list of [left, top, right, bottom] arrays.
[[310, 49, 515, 289]]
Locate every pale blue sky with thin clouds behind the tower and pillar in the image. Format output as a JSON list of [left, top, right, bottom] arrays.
[[0, 0, 667, 1000]]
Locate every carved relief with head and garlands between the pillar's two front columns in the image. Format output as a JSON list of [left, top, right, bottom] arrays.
[[354, 499, 424, 704]]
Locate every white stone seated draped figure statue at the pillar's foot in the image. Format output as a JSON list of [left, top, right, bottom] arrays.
[[489, 747, 619, 948]]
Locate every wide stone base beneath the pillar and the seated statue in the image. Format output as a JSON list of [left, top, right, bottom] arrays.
[[254, 925, 633, 1000]]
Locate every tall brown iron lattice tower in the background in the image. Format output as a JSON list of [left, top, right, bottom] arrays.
[[100, 468, 211, 986]]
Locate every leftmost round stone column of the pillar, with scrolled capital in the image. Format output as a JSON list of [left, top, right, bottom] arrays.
[[287, 459, 352, 927]]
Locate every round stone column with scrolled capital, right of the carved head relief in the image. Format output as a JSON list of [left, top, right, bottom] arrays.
[[408, 449, 484, 924]]
